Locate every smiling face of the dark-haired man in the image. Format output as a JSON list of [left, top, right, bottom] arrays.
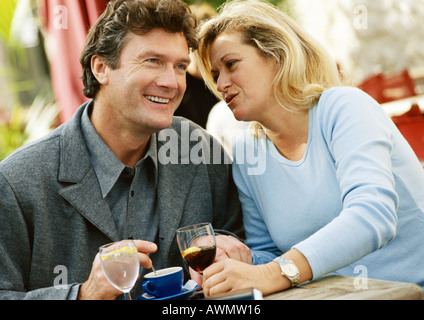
[[99, 29, 190, 134]]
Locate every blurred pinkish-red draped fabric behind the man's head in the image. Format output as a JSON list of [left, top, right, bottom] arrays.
[[39, 0, 108, 123]]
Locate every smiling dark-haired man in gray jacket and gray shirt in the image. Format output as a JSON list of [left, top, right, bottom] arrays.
[[0, 0, 250, 299]]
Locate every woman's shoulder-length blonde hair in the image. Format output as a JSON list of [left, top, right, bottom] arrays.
[[197, 0, 341, 111]]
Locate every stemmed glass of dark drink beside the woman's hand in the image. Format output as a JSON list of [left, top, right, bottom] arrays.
[[177, 222, 216, 281]]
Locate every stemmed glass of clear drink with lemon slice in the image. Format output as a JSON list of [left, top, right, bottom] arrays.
[[99, 240, 140, 300]]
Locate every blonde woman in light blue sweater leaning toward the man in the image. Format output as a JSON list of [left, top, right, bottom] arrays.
[[198, 0, 424, 295]]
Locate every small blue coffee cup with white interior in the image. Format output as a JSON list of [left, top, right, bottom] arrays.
[[141, 267, 184, 298]]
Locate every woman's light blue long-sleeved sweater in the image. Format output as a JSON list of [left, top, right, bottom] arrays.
[[233, 87, 424, 287]]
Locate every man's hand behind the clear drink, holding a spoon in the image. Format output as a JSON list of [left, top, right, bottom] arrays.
[[78, 240, 157, 300]]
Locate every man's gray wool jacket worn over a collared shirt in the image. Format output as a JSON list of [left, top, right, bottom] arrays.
[[0, 103, 242, 299]]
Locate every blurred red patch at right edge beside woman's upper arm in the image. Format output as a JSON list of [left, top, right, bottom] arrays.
[[392, 104, 424, 163]]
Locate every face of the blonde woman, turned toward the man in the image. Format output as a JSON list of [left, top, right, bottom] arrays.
[[210, 31, 278, 122]]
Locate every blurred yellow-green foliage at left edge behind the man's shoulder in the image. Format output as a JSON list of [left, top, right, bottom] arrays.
[[0, 0, 58, 161]]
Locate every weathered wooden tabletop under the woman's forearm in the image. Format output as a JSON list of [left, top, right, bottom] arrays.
[[264, 276, 424, 300]]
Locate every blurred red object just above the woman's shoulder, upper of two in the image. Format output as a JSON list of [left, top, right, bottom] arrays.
[[358, 69, 416, 103]]
